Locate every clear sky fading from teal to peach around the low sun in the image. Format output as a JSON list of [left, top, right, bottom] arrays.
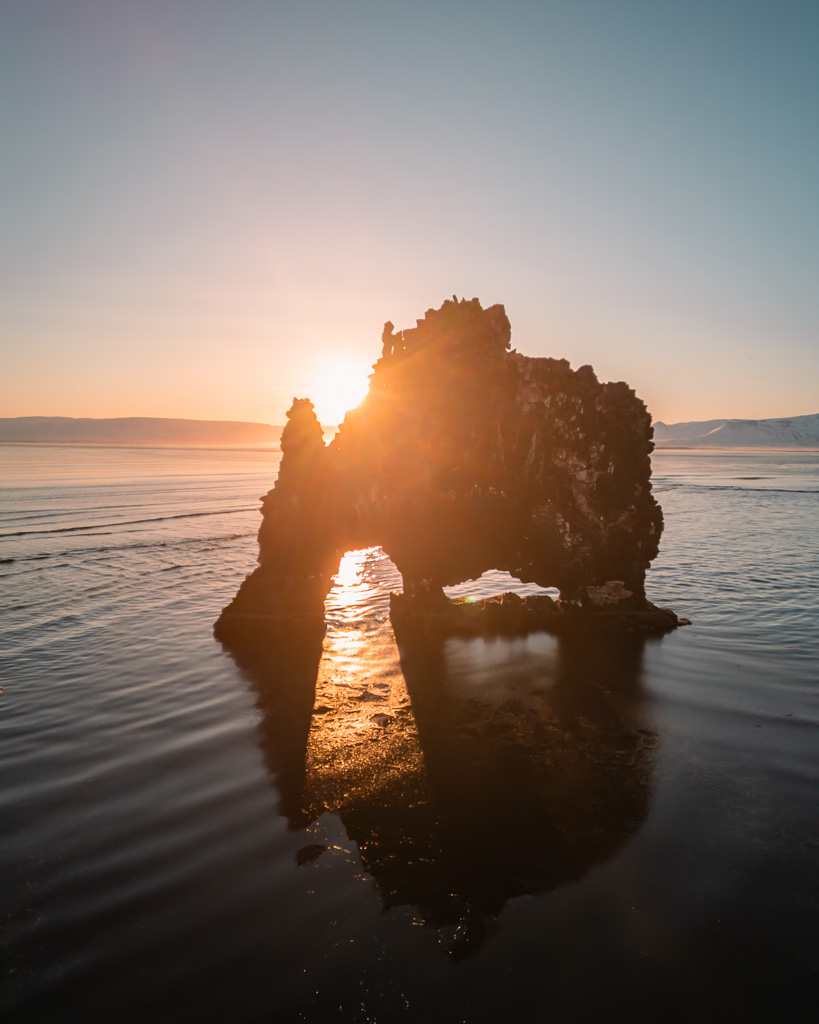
[[0, 0, 819, 423]]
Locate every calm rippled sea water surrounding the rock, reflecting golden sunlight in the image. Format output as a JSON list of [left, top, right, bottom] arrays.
[[0, 444, 819, 1024]]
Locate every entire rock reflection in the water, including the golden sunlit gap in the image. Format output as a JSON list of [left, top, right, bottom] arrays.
[[217, 634, 656, 956]]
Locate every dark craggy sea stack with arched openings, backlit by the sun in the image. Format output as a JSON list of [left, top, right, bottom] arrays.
[[216, 298, 679, 639]]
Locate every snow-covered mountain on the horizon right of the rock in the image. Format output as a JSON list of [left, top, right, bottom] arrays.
[[654, 413, 819, 449]]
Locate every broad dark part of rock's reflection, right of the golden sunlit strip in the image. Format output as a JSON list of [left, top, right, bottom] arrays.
[[352, 643, 652, 937]]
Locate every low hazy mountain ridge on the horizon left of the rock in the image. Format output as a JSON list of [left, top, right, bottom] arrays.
[[0, 416, 282, 444]]
